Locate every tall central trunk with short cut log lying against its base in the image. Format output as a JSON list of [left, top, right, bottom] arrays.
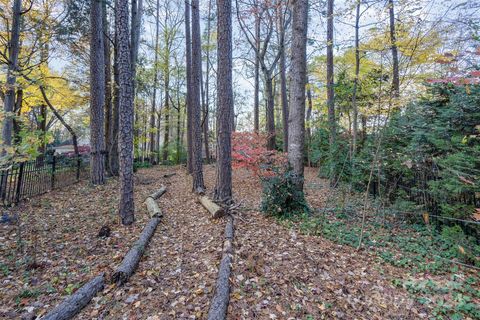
[[214, 0, 233, 204]]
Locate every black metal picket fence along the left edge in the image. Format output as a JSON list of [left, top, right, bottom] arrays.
[[0, 156, 88, 206]]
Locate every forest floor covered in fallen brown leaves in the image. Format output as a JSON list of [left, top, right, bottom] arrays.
[[0, 166, 480, 320]]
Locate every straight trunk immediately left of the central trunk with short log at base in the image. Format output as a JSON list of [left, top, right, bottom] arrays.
[[192, 0, 205, 193]]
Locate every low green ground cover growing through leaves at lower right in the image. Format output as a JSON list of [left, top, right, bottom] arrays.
[[281, 209, 480, 319]]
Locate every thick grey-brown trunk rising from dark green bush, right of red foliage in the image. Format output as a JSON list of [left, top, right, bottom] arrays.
[[288, 0, 308, 192]]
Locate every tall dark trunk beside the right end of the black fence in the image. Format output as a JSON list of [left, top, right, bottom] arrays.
[[90, 0, 105, 185]]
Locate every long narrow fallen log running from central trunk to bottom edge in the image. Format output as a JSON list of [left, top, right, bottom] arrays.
[[207, 216, 234, 320]]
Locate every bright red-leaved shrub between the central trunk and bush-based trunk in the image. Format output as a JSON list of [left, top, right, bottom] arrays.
[[232, 132, 287, 178]]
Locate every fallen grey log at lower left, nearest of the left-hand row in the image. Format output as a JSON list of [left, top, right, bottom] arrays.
[[41, 273, 105, 320]]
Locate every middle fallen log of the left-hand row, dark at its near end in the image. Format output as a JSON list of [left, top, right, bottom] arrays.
[[111, 215, 161, 285]]
